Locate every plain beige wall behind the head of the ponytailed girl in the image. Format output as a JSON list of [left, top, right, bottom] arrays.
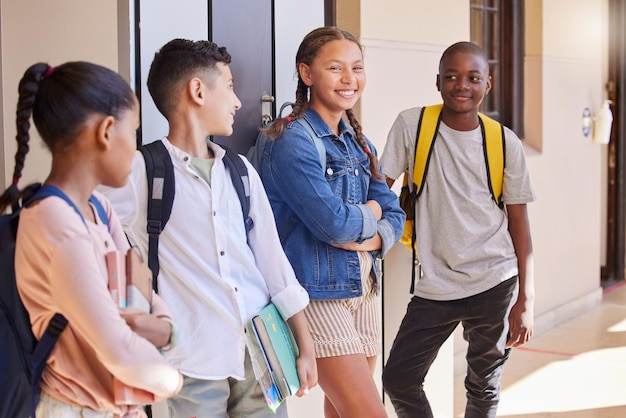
[[0, 0, 118, 185]]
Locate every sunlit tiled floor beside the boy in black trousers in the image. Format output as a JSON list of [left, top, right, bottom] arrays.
[[454, 284, 626, 418]]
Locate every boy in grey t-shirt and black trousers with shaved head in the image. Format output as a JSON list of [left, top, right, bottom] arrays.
[[380, 42, 535, 418]]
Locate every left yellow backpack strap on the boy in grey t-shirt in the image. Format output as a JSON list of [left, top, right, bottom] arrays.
[[413, 104, 443, 199]]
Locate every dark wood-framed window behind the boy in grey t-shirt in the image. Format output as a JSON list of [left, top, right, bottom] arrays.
[[470, 0, 524, 138]]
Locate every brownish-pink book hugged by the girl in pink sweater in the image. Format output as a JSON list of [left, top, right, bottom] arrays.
[[105, 249, 154, 405]]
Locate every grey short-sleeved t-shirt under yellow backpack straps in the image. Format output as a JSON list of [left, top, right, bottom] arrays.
[[380, 108, 535, 300]]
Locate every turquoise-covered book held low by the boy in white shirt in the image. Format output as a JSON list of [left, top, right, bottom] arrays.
[[247, 303, 300, 411]]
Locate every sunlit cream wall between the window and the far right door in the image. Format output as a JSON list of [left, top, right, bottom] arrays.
[[525, 0, 608, 330]]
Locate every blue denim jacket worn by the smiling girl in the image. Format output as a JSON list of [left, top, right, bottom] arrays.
[[260, 108, 405, 300]]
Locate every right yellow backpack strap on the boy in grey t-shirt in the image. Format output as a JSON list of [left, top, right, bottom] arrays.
[[478, 113, 505, 209]]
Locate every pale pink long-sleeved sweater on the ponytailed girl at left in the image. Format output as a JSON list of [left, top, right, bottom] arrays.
[[15, 194, 181, 416]]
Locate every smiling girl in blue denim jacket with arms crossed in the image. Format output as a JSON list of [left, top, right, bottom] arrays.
[[261, 27, 405, 418]]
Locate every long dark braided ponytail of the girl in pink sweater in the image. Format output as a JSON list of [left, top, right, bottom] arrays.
[[0, 63, 52, 213]]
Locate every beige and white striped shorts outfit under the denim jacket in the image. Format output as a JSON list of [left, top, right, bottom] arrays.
[[304, 252, 381, 358]]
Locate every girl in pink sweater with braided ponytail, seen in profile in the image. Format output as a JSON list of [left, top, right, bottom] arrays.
[[0, 62, 182, 418]]
